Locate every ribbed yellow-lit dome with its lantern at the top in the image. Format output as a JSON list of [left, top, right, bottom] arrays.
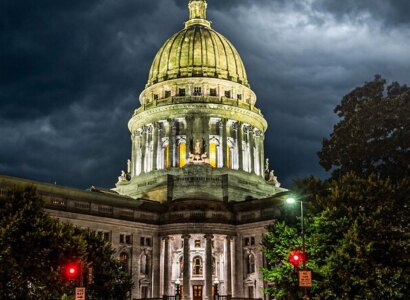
[[147, 0, 249, 87]]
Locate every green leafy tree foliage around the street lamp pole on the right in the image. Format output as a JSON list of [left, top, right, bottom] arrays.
[[263, 173, 410, 299]]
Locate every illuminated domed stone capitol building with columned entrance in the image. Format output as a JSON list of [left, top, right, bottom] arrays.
[[0, 0, 287, 300]]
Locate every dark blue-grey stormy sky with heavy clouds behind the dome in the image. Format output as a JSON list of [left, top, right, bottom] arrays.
[[0, 0, 410, 188]]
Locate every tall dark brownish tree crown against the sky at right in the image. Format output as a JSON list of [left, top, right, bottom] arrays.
[[318, 75, 410, 180]]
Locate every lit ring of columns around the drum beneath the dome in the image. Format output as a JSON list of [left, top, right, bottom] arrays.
[[129, 116, 264, 177]]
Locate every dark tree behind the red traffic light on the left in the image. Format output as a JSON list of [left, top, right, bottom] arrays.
[[0, 187, 132, 299]]
